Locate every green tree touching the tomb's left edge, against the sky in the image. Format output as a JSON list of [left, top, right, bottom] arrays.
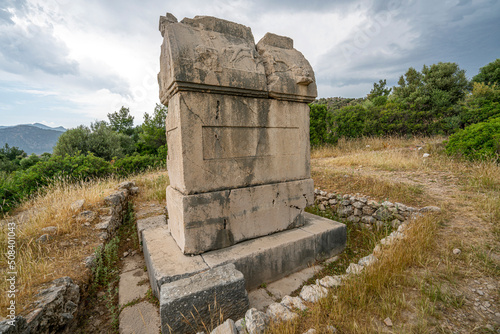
[[139, 104, 168, 154]]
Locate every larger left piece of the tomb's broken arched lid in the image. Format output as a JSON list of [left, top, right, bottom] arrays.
[[158, 14, 267, 102]]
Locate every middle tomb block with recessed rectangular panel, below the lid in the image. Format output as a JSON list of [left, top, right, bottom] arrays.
[[167, 92, 311, 196]]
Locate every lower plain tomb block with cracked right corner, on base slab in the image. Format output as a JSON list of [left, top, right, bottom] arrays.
[[167, 179, 314, 254]]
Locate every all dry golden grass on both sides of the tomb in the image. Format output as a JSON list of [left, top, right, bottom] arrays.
[[0, 137, 500, 334]]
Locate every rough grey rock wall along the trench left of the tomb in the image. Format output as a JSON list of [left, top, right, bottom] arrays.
[[0, 182, 138, 334]]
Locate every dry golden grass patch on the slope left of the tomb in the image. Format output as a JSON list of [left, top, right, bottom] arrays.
[[0, 178, 124, 315]]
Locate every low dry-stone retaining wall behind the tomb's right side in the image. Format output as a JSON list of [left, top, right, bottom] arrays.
[[314, 189, 440, 229]]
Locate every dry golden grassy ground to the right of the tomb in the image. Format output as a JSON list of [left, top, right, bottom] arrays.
[[269, 137, 500, 334]]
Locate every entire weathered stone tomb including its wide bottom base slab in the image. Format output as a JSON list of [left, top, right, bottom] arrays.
[[146, 13, 346, 332]]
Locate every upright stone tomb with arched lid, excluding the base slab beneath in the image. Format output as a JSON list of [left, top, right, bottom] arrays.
[[158, 14, 317, 254]]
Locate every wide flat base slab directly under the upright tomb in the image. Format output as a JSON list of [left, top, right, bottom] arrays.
[[142, 213, 346, 297]]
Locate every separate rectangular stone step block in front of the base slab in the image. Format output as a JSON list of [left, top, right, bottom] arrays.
[[160, 264, 249, 333]]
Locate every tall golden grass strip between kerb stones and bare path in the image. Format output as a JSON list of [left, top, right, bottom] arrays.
[[270, 216, 441, 333]]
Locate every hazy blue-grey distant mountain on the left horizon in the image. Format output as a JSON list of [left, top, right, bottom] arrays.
[[0, 123, 66, 154]]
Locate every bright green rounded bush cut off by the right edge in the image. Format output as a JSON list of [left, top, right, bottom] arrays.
[[446, 118, 500, 162]]
